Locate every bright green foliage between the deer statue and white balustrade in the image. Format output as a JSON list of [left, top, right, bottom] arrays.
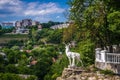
[[78, 39, 95, 66]]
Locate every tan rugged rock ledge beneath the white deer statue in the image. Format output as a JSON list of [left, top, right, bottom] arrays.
[[56, 68, 120, 80]]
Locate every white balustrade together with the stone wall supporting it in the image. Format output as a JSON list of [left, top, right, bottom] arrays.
[[95, 45, 120, 74]]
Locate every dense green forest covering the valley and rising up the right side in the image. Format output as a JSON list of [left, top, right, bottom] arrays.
[[0, 0, 120, 80]]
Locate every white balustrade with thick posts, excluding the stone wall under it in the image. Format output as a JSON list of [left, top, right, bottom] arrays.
[[95, 45, 120, 64]]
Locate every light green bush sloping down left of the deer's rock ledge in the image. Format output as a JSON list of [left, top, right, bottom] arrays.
[[44, 55, 68, 80]]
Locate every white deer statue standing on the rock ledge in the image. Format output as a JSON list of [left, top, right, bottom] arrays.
[[65, 44, 83, 67]]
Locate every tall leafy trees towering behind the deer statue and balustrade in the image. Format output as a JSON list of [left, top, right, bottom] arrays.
[[63, 0, 120, 66]]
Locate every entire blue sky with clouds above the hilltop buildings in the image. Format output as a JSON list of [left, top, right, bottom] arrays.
[[0, 0, 69, 23]]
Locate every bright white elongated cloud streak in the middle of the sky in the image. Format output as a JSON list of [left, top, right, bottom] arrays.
[[24, 2, 64, 16]]
